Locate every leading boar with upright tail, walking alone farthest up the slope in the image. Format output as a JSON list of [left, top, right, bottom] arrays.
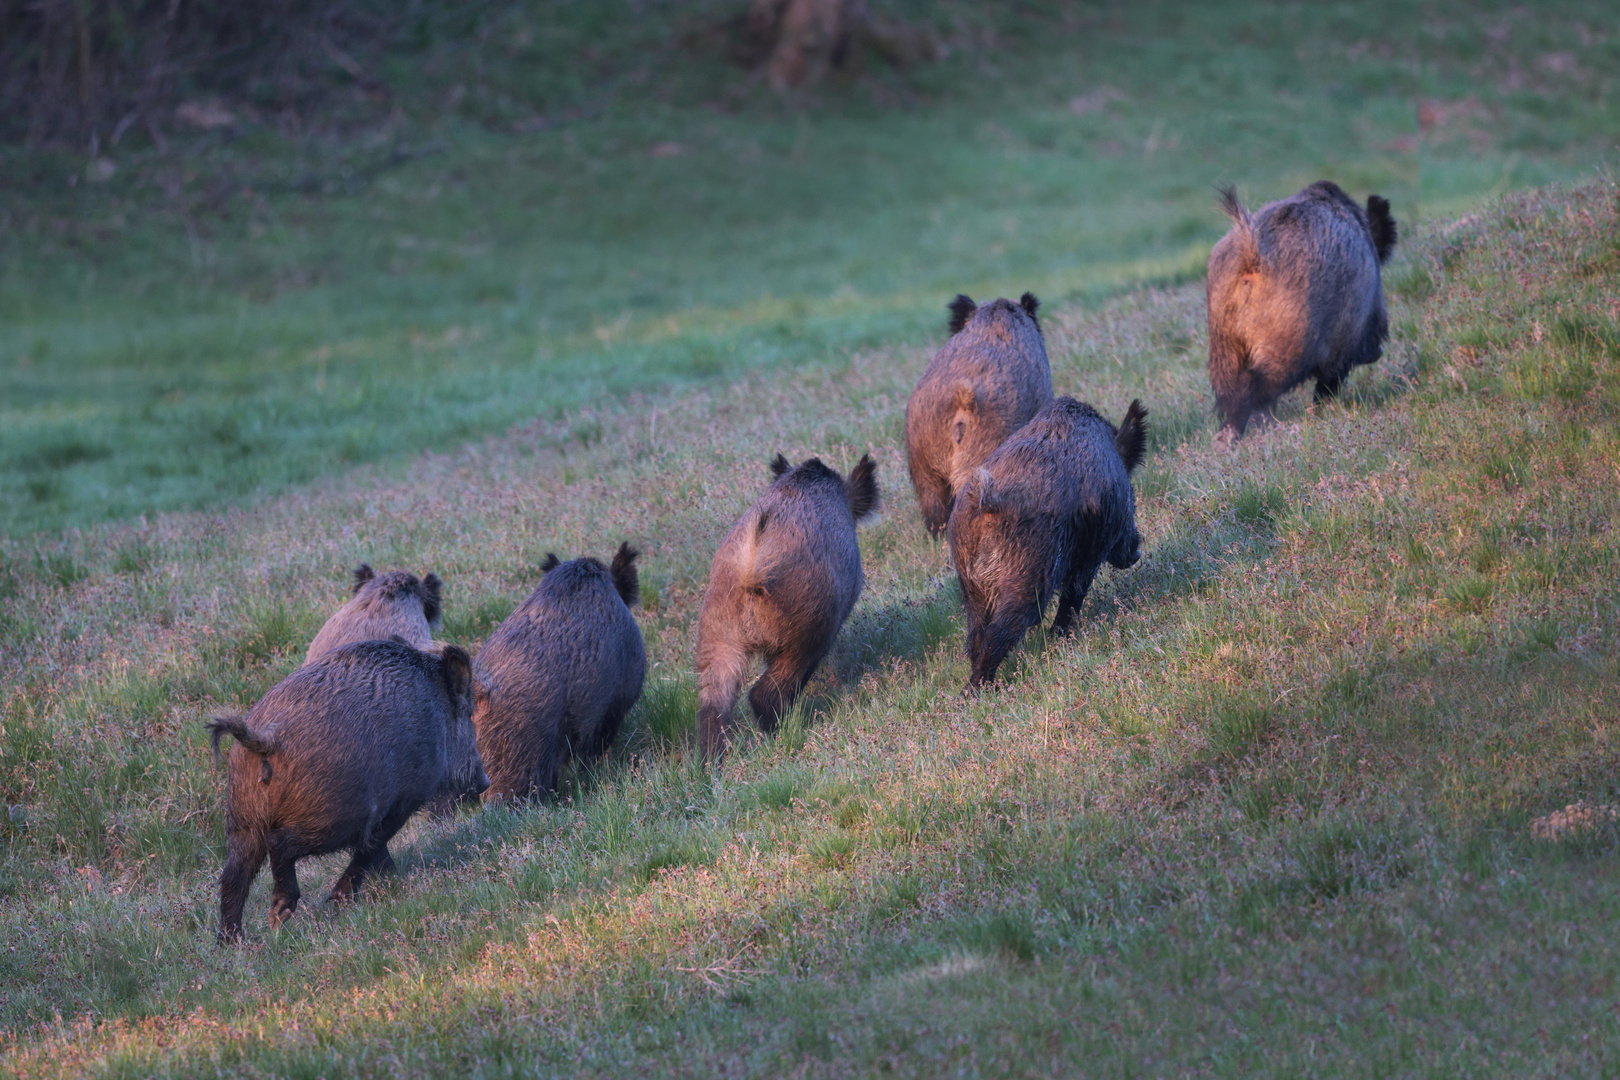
[[1207, 180, 1396, 444]]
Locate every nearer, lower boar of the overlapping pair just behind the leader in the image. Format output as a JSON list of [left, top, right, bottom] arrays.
[[949, 397, 1147, 687]]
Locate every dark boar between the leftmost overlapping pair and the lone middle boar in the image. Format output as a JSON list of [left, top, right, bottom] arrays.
[[473, 544, 646, 801]]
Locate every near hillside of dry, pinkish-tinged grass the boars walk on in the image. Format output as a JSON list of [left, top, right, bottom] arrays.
[[0, 173, 1620, 1075]]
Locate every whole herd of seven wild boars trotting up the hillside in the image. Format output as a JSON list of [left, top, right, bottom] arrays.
[[209, 181, 1396, 942]]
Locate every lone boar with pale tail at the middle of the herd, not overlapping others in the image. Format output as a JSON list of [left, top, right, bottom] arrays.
[[698, 453, 880, 756]]
